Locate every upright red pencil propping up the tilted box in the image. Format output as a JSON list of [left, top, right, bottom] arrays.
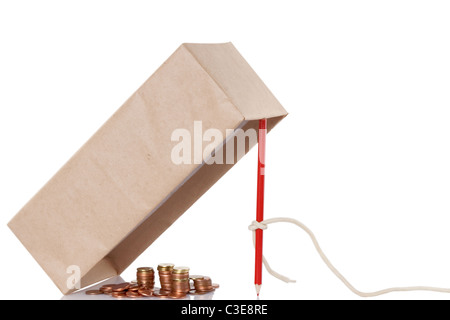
[[255, 119, 267, 296]]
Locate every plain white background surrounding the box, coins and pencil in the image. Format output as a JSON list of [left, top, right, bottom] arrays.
[[0, 0, 450, 299]]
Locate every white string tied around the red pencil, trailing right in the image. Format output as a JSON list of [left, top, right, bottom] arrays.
[[248, 218, 450, 297]]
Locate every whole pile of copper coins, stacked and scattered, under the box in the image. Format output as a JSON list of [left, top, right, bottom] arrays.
[[86, 263, 219, 299]]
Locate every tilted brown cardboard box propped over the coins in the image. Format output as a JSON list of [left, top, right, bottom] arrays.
[[8, 43, 287, 294]]
